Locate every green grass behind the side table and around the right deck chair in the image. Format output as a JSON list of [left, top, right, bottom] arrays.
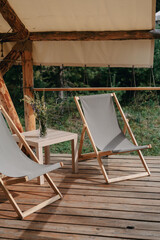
[[44, 92, 160, 156]]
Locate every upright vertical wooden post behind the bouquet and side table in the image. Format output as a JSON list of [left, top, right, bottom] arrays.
[[22, 41, 36, 131]]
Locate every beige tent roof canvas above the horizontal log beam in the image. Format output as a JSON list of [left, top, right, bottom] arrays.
[[0, 0, 155, 32]]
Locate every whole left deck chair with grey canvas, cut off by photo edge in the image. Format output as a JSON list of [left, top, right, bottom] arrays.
[[0, 106, 63, 219]]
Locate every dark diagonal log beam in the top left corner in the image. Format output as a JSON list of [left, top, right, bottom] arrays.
[[0, 0, 29, 40]]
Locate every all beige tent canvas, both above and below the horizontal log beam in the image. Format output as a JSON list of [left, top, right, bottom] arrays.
[[0, 0, 155, 67]]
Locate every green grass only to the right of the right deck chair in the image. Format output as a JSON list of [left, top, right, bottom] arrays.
[[120, 93, 160, 156]]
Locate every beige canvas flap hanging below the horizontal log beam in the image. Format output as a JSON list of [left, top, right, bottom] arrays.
[[33, 40, 154, 67]]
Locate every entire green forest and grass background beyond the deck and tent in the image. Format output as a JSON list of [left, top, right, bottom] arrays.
[[4, 0, 160, 156]]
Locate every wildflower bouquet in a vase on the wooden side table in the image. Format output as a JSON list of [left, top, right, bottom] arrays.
[[23, 93, 47, 137]]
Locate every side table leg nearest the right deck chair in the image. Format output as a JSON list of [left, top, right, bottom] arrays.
[[71, 136, 78, 173]]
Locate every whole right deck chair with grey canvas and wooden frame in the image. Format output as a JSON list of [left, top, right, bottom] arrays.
[[75, 93, 151, 183]]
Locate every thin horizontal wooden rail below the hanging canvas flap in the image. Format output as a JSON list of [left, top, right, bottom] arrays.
[[33, 87, 160, 92]]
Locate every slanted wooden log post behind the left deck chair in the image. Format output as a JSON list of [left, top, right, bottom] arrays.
[[0, 73, 23, 132]]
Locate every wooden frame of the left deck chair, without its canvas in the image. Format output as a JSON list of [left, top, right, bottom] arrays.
[[0, 106, 63, 219]]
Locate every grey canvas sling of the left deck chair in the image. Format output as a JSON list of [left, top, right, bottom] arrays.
[[0, 110, 60, 180]]
